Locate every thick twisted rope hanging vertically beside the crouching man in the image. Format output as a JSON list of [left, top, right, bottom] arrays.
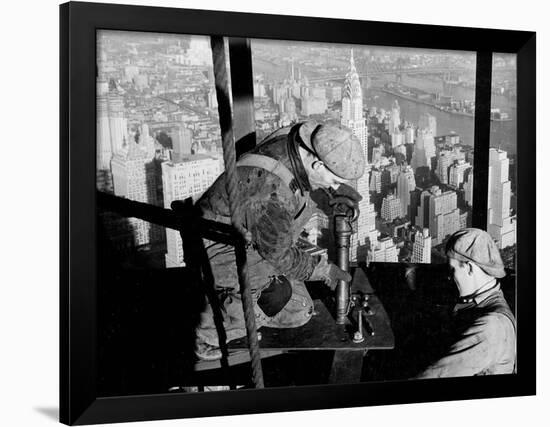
[[210, 36, 264, 388]]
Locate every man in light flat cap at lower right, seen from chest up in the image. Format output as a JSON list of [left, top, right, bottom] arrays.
[[417, 228, 516, 378]]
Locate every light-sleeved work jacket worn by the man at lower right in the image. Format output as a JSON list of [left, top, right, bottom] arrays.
[[417, 287, 516, 378]]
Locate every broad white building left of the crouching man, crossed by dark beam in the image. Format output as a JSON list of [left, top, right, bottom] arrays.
[[162, 154, 222, 268]]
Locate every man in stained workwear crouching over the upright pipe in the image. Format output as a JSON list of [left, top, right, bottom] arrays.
[[196, 122, 365, 360]]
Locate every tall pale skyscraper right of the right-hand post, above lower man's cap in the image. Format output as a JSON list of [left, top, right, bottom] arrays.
[[487, 148, 516, 248]]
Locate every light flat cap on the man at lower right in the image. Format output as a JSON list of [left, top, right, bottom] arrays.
[[446, 228, 506, 278]]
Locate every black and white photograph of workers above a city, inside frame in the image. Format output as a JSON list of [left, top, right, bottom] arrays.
[[96, 30, 517, 395]]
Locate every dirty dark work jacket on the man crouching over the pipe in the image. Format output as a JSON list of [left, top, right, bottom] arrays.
[[197, 124, 319, 280]]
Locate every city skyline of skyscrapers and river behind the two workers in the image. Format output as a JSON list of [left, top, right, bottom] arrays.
[[97, 31, 515, 267]]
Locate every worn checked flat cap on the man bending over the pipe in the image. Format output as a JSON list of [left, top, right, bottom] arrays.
[[299, 121, 365, 180]]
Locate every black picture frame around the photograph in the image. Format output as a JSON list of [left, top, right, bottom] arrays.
[[60, 2, 536, 425]]
